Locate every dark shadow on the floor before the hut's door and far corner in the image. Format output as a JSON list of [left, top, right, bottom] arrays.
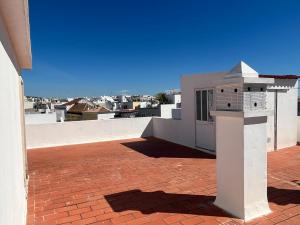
[[121, 137, 216, 159]]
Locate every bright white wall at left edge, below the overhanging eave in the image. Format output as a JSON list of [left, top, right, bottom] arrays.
[[0, 14, 27, 225]]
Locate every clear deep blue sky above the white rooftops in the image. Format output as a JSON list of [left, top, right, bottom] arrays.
[[23, 0, 300, 97]]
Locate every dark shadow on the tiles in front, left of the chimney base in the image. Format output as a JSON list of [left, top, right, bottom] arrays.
[[105, 190, 228, 216]]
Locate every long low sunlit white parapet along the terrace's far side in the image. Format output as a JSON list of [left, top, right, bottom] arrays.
[[26, 117, 152, 148]]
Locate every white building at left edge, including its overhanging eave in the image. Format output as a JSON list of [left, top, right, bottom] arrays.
[[0, 0, 32, 225]]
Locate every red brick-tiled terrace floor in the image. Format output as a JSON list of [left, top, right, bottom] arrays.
[[28, 138, 300, 225]]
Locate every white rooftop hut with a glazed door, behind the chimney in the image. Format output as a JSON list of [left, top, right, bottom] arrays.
[[181, 62, 298, 151]]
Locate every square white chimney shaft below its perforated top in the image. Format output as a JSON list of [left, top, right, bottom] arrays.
[[212, 111, 270, 221]]
